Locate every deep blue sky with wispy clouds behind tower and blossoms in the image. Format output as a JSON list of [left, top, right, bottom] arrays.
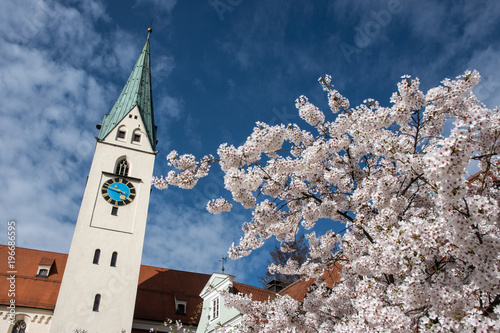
[[0, 0, 500, 285]]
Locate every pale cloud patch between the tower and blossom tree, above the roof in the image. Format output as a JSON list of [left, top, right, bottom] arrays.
[[144, 195, 243, 273]]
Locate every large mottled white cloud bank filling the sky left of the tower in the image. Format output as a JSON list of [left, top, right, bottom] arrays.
[[0, 0, 138, 252]]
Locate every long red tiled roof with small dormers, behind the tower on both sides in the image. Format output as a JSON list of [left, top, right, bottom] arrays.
[[0, 245, 210, 323]]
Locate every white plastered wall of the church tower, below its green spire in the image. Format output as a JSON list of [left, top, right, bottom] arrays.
[[50, 106, 155, 333]]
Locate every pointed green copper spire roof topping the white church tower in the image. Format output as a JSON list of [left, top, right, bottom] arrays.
[[98, 30, 156, 150]]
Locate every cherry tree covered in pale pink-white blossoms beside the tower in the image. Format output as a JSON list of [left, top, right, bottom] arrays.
[[153, 71, 500, 332]]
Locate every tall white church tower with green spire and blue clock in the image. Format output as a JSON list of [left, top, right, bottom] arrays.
[[50, 29, 156, 333]]
